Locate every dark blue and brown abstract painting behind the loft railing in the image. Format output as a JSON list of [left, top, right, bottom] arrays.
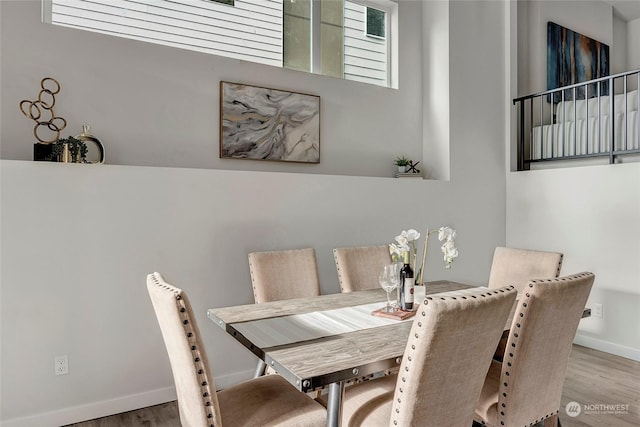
[[547, 22, 609, 103]]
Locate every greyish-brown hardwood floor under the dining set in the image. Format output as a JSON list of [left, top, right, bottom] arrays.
[[69, 345, 640, 427]]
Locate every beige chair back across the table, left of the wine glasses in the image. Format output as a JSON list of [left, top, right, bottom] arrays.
[[249, 248, 320, 303]]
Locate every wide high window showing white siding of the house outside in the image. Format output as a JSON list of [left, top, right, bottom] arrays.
[[42, 0, 398, 87]]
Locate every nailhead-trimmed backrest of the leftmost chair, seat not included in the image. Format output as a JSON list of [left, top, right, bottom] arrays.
[[147, 273, 221, 427]]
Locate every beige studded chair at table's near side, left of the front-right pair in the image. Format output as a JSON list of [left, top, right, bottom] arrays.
[[320, 286, 516, 427]]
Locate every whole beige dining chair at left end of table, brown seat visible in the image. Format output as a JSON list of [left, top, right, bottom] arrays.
[[147, 273, 327, 427]]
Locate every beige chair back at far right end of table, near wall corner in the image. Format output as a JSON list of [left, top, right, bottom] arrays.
[[487, 247, 563, 292]]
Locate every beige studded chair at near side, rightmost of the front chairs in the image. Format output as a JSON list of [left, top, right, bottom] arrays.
[[475, 273, 595, 427]]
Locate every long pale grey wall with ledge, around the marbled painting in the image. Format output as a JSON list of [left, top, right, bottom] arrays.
[[0, 1, 509, 427]]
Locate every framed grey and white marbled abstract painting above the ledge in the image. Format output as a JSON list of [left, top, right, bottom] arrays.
[[220, 81, 320, 163]]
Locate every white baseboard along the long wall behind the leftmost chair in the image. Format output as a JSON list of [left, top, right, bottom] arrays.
[[0, 371, 253, 427]]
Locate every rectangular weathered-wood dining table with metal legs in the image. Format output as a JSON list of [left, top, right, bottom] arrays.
[[207, 280, 587, 427]]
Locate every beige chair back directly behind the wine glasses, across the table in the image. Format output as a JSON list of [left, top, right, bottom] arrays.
[[333, 245, 391, 292]]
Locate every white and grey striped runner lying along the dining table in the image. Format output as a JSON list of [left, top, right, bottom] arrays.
[[233, 286, 488, 349]]
